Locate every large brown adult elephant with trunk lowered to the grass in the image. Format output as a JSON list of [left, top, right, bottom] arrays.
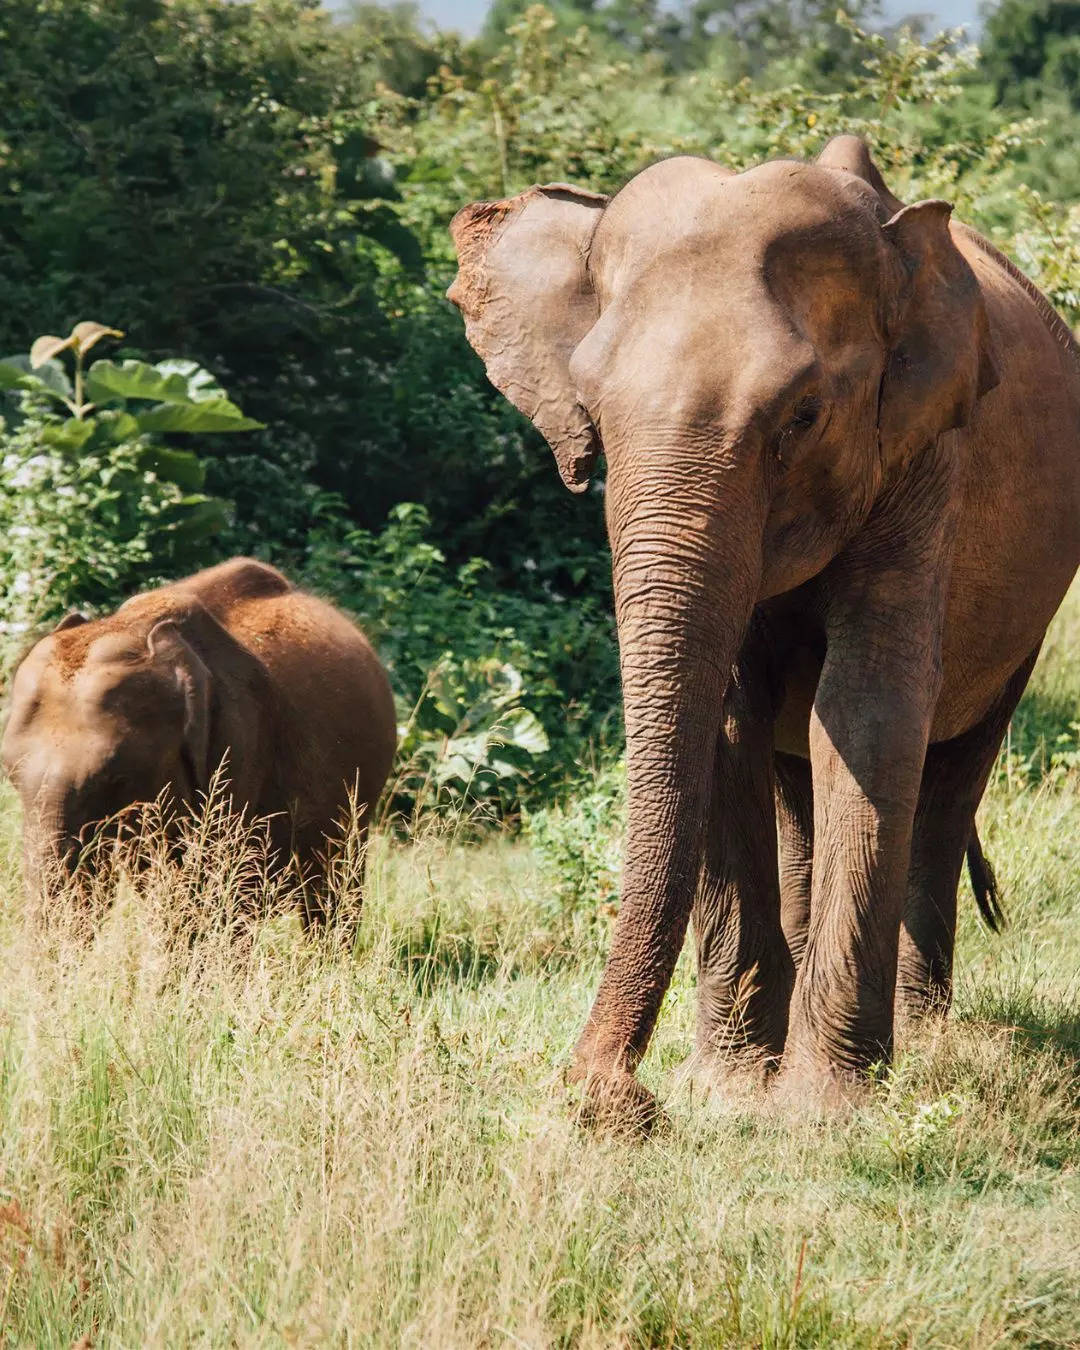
[[450, 136, 1080, 1114]]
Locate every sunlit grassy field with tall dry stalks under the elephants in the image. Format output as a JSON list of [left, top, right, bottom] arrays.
[[0, 591, 1080, 1347]]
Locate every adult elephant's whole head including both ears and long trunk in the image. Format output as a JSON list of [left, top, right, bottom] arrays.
[[450, 136, 996, 1096]]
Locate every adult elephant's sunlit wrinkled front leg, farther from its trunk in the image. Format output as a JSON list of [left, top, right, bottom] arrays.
[[784, 579, 941, 1095]]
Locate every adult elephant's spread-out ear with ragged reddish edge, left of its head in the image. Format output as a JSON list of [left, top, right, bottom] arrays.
[[447, 184, 608, 493]]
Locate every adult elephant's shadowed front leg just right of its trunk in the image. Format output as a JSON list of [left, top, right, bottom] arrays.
[[694, 684, 795, 1072]]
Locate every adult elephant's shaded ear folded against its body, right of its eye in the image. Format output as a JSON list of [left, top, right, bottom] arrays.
[[878, 200, 999, 462]]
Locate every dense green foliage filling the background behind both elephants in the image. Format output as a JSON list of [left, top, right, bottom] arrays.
[[0, 0, 1080, 813]]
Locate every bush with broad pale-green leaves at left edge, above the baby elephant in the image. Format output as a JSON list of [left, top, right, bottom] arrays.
[[0, 323, 258, 657]]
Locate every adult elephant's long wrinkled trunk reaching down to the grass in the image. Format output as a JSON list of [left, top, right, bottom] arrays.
[[575, 452, 764, 1079]]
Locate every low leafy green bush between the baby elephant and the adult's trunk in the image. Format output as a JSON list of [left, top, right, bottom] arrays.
[[304, 500, 621, 819]]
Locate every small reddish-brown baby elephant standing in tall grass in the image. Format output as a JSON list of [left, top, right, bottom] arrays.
[[3, 558, 396, 927]]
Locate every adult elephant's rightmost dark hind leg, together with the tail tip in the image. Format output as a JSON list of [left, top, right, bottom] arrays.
[[896, 649, 1038, 1018]]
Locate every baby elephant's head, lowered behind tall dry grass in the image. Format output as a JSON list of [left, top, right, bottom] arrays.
[[3, 614, 209, 880]]
